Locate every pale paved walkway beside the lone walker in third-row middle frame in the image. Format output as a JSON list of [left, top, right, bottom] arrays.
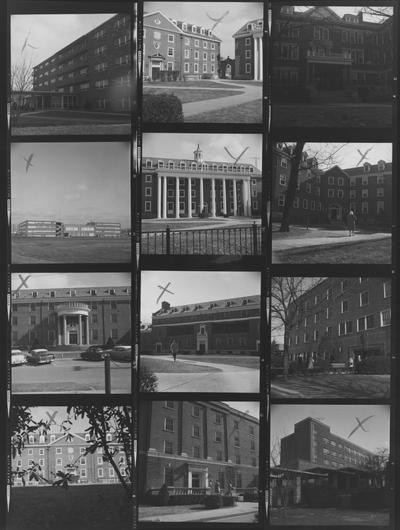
[[148, 356, 260, 392]]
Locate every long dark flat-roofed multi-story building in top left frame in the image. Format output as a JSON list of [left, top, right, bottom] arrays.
[[30, 13, 133, 111]]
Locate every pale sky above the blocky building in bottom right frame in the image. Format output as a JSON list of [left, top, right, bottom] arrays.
[[271, 403, 390, 452]]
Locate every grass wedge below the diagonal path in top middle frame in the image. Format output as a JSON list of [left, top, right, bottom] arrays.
[[185, 99, 262, 123]]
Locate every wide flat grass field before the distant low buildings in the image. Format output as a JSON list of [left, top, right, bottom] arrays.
[[11, 237, 131, 263]]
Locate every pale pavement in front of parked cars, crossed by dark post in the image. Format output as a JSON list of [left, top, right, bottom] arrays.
[[11, 359, 131, 393]]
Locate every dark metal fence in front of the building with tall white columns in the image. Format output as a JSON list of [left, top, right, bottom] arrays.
[[142, 223, 261, 256]]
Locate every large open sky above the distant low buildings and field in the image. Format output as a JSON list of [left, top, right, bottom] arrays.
[[11, 142, 130, 228]]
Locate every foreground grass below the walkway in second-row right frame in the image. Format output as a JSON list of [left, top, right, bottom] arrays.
[[272, 237, 392, 264]]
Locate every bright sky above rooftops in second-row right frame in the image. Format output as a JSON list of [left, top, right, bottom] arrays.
[[304, 142, 393, 170]]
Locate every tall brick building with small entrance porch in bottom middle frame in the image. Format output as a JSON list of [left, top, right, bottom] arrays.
[[138, 401, 259, 495]]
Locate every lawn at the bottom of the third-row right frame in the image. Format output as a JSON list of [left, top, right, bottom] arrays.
[[271, 374, 390, 399]]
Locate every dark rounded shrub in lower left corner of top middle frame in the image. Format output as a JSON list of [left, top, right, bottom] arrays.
[[143, 94, 183, 123]]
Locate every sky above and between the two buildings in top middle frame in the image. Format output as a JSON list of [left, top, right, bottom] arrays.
[[144, 2, 263, 58]]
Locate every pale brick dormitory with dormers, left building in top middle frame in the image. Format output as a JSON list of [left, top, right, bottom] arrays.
[[143, 11, 221, 81]]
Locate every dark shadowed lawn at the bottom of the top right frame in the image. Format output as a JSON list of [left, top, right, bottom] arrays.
[[272, 103, 392, 128]]
